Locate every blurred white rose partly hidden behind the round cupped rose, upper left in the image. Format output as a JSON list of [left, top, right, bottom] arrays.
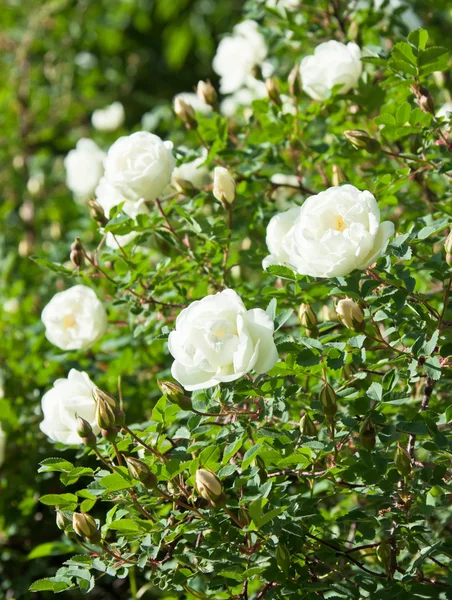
[[64, 138, 105, 198]]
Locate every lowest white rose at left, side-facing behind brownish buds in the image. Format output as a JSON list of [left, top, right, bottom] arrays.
[[39, 369, 100, 444]]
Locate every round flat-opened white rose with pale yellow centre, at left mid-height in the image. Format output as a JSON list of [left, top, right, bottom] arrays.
[[41, 285, 107, 350]]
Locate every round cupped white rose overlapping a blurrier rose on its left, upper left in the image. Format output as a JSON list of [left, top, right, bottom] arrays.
[[105, 131, 174, 200]]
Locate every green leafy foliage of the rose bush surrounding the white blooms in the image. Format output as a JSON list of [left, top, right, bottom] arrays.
[[0, 0, 452, 599]]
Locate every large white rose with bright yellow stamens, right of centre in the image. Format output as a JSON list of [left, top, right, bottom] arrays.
[[263, 184, 394, 277]]
